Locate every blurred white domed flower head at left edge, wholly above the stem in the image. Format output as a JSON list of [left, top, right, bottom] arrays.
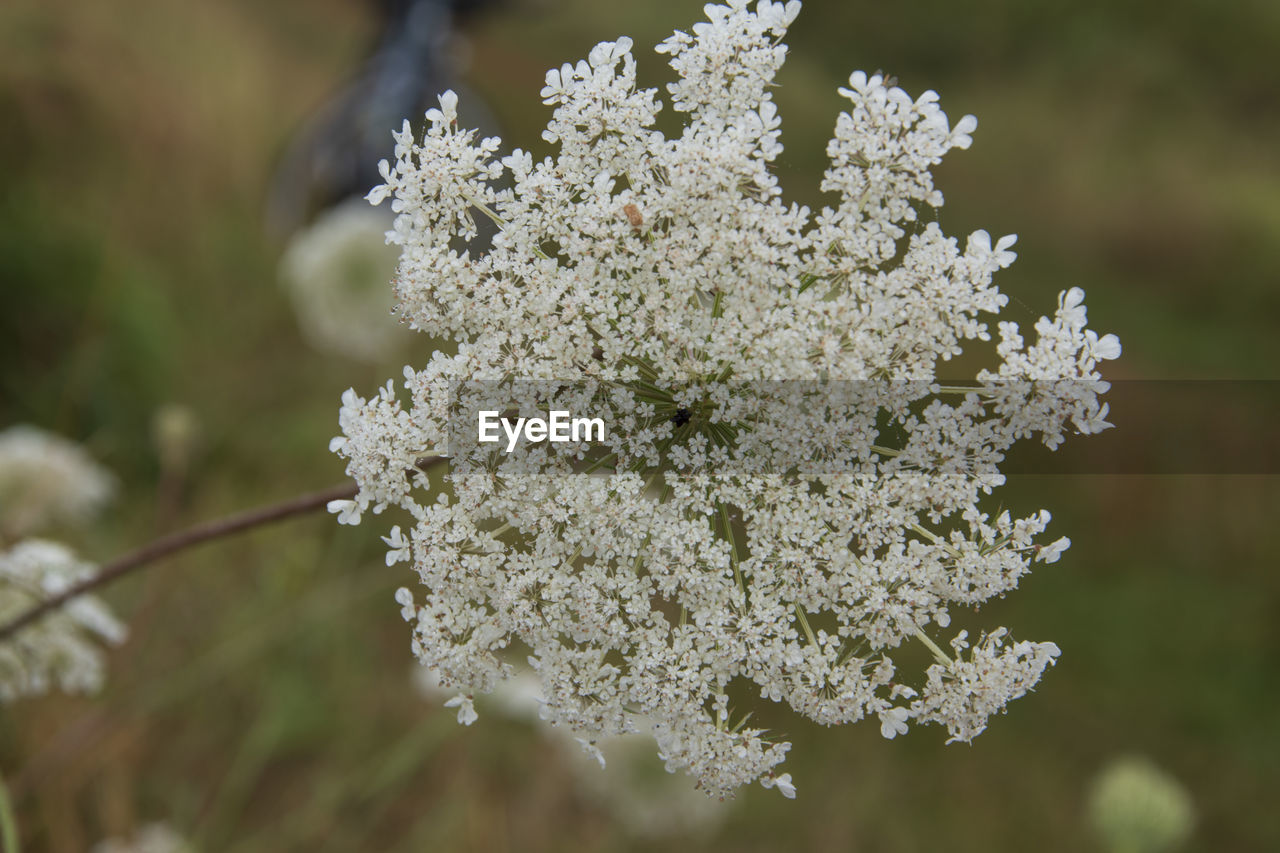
[[0, 424, 115, 539]]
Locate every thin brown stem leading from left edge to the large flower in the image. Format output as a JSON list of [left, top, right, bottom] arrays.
[[0, 483, 357, 642]]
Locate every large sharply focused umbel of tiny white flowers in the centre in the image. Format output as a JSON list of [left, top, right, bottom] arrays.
[[330, 1, 1120, 797]]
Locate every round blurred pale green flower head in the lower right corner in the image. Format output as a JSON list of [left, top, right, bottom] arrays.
[[1089, 756, 1196, 853]]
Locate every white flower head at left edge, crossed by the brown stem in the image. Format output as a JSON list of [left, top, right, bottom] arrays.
[[0, 539, 125, 702]]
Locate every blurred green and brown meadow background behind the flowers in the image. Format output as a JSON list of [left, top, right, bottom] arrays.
[[0, 0, 1280, 852]]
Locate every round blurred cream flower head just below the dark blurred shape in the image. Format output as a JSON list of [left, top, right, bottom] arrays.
[[280, 199, 406, 361]]
